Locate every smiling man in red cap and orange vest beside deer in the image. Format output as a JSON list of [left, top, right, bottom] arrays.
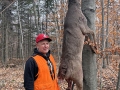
[[24, 34, 60, 90]]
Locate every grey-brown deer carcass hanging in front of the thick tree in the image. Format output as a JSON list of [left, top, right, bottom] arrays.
[[58, 0, 95, 90]]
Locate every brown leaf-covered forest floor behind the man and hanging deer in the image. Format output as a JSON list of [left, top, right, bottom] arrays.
[[0, 54, 119, 90]]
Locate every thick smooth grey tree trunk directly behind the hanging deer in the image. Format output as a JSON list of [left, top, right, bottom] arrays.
[[81, 0, 97, 90]]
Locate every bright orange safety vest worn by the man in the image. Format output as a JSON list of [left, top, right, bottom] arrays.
[[33, 55, 60, 90]]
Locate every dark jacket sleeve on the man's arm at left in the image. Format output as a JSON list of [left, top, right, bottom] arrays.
[[24, 57, 38, 90]]
